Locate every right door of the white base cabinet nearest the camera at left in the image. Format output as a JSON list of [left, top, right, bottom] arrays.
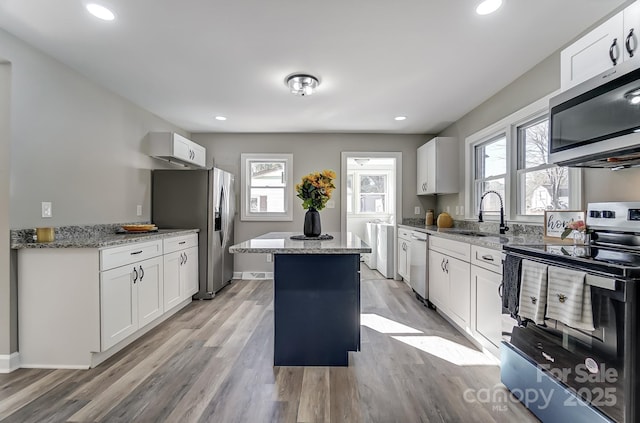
[[134, 257, 164, 328]]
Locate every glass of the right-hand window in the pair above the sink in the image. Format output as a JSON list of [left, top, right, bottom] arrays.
[[517, 116, 569, 215]]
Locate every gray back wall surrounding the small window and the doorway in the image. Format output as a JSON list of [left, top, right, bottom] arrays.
[[191, 134, 431, 272]]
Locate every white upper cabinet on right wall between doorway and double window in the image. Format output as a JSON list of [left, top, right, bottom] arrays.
[[416, 137, 459, 195]]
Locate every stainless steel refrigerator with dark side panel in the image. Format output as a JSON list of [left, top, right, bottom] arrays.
[[151, 168, 236, 299]]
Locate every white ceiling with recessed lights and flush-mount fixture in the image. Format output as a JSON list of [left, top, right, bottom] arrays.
[[0, 0, 625, 133]]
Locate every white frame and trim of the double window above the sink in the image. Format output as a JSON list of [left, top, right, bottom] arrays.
[[465, 91, 583, 224]]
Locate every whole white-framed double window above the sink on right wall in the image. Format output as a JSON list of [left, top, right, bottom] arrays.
[[465, 95, 582, 221]]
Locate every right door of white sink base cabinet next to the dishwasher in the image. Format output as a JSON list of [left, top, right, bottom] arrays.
[[445, 257, 471, 328]]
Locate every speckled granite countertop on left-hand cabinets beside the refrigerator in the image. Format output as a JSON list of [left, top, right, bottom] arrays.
[[11, 229, 200, 250]]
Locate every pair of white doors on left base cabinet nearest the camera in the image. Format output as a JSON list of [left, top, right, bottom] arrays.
[[100, 257, 164, 351]]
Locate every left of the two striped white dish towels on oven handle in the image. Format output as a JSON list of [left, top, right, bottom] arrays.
[[518, 259, 547, 325]]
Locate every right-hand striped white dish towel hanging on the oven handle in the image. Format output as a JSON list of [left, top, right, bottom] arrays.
[[547, 266, 594, 331]]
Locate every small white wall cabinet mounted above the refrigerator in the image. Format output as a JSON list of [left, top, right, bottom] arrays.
[[149, 132, 207, 168]]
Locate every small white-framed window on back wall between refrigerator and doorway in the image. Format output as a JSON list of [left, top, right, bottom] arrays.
[[241, 154, 293, 221]]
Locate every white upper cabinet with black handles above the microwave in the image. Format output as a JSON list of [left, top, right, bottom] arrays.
[[560, 2, 640, 91]]
